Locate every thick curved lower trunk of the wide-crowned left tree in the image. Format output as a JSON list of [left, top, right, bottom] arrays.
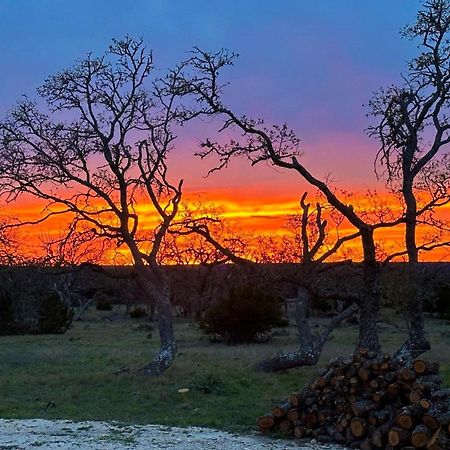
[[137, 268, 177, 376]]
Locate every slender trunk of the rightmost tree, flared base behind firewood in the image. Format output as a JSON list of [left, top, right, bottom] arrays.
[[394, 185, 431, 364]]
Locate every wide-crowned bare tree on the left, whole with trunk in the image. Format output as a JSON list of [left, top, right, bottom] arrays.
[[0, 37, 196, 375]]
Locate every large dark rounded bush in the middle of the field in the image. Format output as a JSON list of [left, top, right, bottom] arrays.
[[198, 286, 285, 344]]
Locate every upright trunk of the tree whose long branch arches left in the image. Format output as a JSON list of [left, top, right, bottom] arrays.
[[358, 230, 381, 352]]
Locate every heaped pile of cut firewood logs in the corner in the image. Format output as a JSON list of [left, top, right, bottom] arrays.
[[258, 349, 450, 450]]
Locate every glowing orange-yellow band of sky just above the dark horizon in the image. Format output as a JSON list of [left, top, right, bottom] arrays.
[[1, 186, 450, 261]]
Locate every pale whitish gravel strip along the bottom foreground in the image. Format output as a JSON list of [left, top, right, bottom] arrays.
[[0, 419, 348, 450]]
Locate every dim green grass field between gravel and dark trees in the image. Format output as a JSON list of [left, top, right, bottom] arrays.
[[0, 313, 450, 431]]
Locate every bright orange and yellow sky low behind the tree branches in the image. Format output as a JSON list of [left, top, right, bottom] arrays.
[[3, 184, 450, 261]]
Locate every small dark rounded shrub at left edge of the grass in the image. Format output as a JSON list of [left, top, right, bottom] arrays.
[[36, 292, 73, 334]]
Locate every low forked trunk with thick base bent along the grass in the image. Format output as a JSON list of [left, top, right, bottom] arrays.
[[256, 287, 358, 372]]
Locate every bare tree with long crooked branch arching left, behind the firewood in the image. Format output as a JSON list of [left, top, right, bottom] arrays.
[[176, 48, 403, 351]]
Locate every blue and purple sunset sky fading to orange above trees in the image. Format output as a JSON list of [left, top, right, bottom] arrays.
[[0, 0, 446, 259]]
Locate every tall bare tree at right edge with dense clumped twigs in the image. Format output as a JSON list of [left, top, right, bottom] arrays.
[[368, 0, 450, 361]]
